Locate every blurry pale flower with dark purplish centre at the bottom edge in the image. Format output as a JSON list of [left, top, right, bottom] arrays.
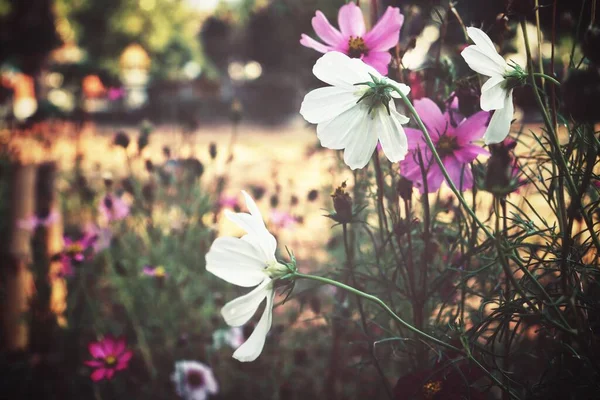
[[171, 361, 219, 400]]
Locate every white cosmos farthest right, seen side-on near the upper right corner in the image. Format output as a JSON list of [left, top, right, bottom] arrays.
[[461, 27, 514, 144]]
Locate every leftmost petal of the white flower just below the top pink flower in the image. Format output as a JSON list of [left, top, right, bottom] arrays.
[[300, 86, 360, 124]]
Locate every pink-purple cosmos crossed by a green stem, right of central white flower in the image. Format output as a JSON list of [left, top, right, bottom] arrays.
[[400, 98, 490, 193]]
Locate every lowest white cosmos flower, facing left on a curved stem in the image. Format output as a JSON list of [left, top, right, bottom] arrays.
[[206, 191, 287, 361]]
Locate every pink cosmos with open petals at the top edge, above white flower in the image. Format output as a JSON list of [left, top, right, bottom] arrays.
[[300, 3, 404, 75]]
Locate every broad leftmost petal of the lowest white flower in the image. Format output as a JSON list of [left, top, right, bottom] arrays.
[[206, 237, 268, 287]]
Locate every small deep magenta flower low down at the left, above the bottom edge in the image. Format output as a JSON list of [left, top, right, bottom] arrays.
[[85, 336, 133, 382]]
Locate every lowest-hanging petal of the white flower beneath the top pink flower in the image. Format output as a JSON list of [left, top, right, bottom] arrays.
[[344, 106, 377, 169]]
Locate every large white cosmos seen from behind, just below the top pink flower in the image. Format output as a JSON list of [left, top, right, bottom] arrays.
[[300, 51, 410, 169]]
